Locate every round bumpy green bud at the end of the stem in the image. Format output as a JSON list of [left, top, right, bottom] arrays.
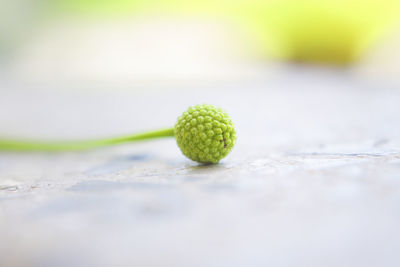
[[174, 105, 236, 163]]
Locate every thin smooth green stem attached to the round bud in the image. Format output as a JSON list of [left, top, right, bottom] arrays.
[[0, 128, 174, 152]]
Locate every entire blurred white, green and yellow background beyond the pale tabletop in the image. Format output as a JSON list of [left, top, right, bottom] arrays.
[[0, 0, 400, 87]]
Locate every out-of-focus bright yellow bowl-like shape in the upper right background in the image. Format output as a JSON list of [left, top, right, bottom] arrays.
[[237, 0, 400, 64]]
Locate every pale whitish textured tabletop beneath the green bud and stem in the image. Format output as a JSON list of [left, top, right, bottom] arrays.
[[0, 69, 400, 267]]
